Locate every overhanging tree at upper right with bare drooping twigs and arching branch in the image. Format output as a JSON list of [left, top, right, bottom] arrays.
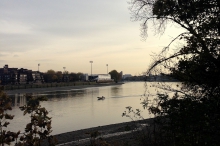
[[130, 0, 220, 94]]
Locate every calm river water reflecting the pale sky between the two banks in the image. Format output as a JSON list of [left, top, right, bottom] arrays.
[[7, 82, 171, 134]]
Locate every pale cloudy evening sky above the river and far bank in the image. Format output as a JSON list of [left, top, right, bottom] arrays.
[[0, 0, 184, 75]]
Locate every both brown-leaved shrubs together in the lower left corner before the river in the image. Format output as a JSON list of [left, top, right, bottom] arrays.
[[0, 87, 57, 146]]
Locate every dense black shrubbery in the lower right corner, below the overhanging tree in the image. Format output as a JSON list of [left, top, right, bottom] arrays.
[[146, 94, 220, 146]]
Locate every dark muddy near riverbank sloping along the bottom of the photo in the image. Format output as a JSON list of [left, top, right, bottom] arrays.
[[43, 118, 153, 146]]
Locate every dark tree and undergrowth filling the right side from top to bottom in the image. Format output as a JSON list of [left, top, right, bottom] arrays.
[[127, 0, 220, 145]]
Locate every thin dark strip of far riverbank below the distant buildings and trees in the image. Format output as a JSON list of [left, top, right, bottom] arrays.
[[5, 83, 124, 95]]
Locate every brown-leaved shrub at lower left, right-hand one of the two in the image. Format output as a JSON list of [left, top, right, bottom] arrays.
[[17, 95, 56, 146]]
